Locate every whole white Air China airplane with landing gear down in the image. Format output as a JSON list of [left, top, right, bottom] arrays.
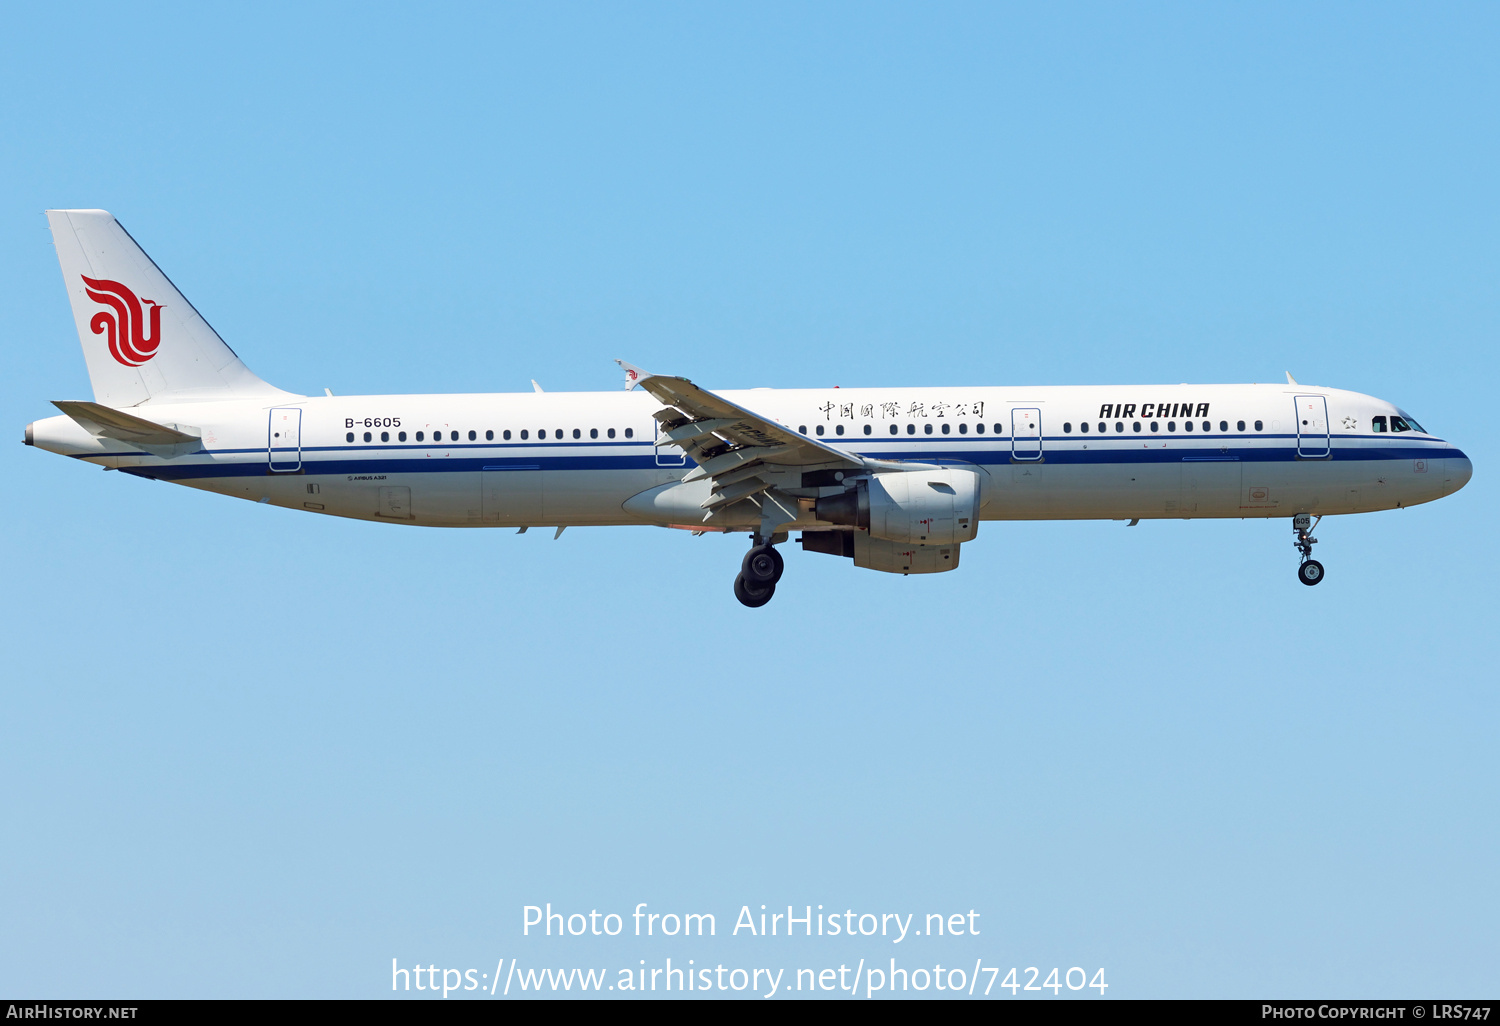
[[26, 210, 1473, 608]]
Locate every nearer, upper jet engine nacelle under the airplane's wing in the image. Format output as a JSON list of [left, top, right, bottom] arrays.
[[813, 467, 980, 546]]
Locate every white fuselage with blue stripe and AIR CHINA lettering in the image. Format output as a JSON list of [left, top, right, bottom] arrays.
[[29, 384, 1472, 530]]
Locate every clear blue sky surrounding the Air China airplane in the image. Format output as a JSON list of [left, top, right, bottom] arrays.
[[0, 5, 1500, 999]]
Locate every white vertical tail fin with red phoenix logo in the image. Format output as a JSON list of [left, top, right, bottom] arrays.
[[47, 210, 288, 408]]
